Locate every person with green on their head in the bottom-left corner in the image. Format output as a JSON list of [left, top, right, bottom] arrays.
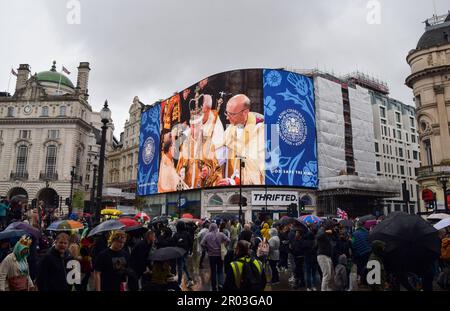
[[0, 236, 34, 291]]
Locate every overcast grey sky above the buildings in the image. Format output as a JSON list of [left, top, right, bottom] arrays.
[[0, 0, 450, 137]]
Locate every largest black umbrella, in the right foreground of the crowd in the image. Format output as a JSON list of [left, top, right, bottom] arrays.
[[369, 213, 441, 273]]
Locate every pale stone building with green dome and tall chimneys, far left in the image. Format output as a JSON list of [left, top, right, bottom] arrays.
[[0, 62, 113, 212]]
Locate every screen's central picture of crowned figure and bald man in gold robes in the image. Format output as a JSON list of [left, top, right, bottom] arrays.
[[158, 70, 265, 192]]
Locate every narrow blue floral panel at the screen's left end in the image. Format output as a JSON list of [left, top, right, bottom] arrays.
[[137, 105, 161, 195]]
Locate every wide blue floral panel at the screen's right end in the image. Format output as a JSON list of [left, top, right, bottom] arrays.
[[263, 69, 318, 188]]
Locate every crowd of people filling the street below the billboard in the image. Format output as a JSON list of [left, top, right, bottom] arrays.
[[0, 201, 450, 291]]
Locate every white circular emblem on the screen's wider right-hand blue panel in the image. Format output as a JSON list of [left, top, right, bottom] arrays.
[[278, 109, 308, 146]]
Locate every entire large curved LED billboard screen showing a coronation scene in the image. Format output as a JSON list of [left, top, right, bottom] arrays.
[[137, 69, 318, 195]]
